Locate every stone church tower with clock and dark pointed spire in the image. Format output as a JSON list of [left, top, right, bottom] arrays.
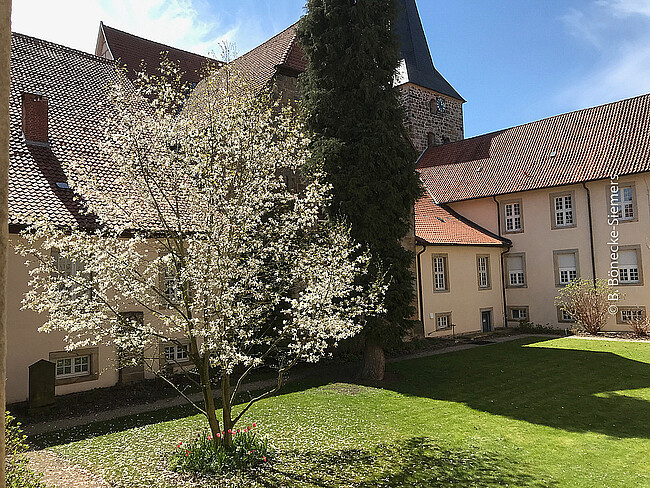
[[395, 0, 465, 152]]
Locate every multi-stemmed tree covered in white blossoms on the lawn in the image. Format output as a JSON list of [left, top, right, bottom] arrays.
[[20, 62, 385, 445]]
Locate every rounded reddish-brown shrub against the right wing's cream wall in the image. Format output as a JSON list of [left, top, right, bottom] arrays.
[[555, 279, 621, 334]]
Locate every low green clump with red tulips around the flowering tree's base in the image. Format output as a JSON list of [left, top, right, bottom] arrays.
[[169, 424, 272, 474]]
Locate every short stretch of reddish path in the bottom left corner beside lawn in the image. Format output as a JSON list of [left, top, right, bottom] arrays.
[[26, 449, 111, 488]]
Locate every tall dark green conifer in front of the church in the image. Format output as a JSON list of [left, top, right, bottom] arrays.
[[298, 0, 420, 379]]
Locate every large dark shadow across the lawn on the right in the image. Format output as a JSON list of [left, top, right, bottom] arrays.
[[382, 339, 650, 438]]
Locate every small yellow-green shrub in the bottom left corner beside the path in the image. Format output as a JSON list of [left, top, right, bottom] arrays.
[[5, 412, 45, 488]]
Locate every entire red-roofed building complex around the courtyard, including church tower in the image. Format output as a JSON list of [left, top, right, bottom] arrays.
[[7, 0, 650, 402]]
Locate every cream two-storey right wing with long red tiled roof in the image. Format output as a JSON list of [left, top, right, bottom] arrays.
[[416, 95, 650, 331]]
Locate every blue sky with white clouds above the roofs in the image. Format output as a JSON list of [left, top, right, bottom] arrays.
[[12, 0, 650, 137]]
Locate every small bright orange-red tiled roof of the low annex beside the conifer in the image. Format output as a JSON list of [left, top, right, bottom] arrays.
[[415, 192, 509, 246]]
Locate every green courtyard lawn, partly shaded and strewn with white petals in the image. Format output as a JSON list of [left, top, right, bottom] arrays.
[[36, 338, 650, 488]]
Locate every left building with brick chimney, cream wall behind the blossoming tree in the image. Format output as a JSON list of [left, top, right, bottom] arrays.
[[6, 33, 128, 403]]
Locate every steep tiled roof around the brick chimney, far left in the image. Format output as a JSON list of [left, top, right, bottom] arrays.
[[9, 33, 120, 226]]
